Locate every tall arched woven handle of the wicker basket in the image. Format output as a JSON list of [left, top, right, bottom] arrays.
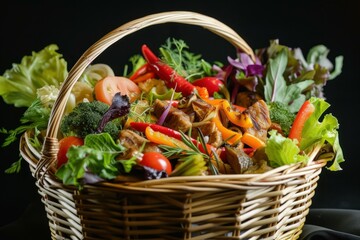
[[35, 11, 255, 177]]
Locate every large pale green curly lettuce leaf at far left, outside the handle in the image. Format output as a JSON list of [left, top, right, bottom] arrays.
[[0, 44, 68, 107]]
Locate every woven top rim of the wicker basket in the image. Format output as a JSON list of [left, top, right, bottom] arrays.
[[19, 131, 327, 189]]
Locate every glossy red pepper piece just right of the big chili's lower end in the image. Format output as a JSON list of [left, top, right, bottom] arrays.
[[192, 77, 230, 100]]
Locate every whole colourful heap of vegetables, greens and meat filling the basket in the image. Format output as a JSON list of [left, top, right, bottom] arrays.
[[0, 38, 344, 187]]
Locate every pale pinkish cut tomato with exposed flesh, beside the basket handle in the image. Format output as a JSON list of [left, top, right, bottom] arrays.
[[94, 76, 141, 105]]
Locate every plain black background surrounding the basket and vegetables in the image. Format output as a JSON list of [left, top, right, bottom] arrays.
[[0, 0, 360, 239]]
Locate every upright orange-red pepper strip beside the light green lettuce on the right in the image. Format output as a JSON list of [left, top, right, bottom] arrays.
[[288, 100, 315, 144]]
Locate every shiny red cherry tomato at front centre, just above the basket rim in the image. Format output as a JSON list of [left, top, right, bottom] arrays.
[[140, 152, 172, 175]]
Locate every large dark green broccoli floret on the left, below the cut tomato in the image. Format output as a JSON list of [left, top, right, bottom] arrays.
[[60, 101, 120, 139]]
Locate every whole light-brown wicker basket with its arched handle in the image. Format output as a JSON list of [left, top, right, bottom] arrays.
[[20, 11, 325, 240]]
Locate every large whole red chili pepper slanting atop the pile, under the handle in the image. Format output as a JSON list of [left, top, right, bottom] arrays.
[[141, 44, 196, 96]]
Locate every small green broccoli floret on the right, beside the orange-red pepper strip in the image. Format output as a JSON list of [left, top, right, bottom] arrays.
[[268, 102, 295, 136]]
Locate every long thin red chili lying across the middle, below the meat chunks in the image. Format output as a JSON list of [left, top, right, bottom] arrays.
[[130, 122, 212, 154]]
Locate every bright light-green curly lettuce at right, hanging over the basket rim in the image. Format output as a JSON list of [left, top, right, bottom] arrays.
[[265, 97, 345, 171]]
